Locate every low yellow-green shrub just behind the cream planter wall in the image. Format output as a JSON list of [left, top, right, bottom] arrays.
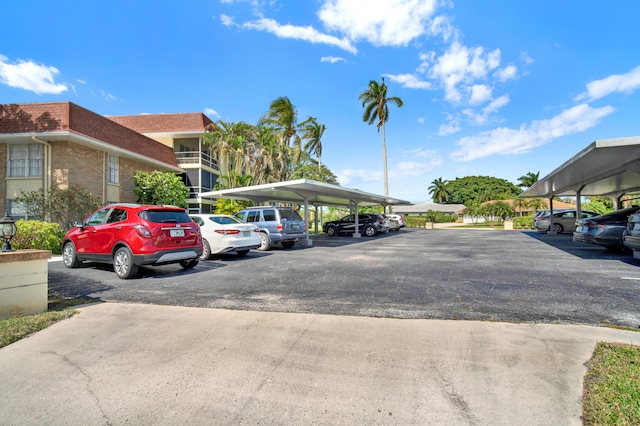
[[11, 219, 64, 254]]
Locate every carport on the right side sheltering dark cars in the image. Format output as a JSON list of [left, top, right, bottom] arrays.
[[520, 136, 640, 231]]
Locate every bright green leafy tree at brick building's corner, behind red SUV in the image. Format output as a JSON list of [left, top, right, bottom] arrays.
[[133, 170, 189, 208]]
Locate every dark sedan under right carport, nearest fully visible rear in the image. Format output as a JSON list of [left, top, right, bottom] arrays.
[[573, 206, 640, 250]]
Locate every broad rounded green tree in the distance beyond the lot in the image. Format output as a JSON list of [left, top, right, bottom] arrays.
[[446, 176, 521, 205]]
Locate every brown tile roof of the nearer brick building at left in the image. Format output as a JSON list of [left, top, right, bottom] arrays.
[[0, 102, 178, 167]]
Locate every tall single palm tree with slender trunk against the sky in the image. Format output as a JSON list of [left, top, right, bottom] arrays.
[[358, 77, 404, 196]]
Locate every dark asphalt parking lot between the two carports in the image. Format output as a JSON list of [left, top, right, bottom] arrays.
[[49, 229, 640, 328]]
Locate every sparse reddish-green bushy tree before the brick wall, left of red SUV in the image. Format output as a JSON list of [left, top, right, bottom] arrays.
[[16, 185, 102, 231]]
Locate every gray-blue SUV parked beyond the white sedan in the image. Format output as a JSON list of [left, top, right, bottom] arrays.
[[235, 206, 306, 251]]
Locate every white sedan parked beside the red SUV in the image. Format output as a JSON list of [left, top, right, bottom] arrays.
[[190, 214, 262, 260]]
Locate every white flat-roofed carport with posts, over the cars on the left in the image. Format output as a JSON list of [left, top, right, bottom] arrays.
[[198, 179, 411, 246]]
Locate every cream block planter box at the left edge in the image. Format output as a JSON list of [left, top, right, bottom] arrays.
[[0, 250, 51, 319]]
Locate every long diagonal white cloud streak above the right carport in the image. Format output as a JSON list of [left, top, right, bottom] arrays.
[[451, 104, 615, 161]]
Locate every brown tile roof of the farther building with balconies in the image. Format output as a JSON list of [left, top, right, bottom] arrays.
[[107, 112, 213, 133]]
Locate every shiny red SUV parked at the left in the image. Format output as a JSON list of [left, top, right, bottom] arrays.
[[62, 204, 202, 279]]
